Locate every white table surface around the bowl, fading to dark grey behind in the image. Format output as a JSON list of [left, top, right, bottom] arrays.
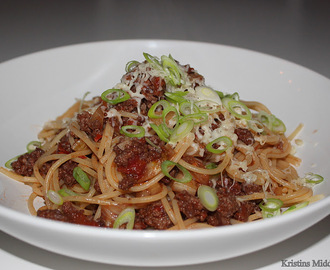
[[0, 0, 330, 270]]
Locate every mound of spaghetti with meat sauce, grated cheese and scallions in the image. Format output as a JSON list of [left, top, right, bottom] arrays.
[[0, 53, 323, 230]]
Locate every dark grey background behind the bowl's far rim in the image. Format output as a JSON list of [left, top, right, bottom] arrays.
[[0, 0, 330, 77]]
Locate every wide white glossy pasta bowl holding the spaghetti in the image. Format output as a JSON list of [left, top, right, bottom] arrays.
[[0, 40, 330, 266]]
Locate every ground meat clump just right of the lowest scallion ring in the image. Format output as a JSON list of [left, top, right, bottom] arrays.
[[137, 201, 173, 230]]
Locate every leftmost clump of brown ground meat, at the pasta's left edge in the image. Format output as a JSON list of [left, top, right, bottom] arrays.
[[11, 148, 44, 176]]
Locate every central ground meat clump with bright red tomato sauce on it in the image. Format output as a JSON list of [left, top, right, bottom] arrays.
[[114, 137, 163, 190]]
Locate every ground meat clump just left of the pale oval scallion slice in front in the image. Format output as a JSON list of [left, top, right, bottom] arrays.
[[175, 191, 207, 221]]
